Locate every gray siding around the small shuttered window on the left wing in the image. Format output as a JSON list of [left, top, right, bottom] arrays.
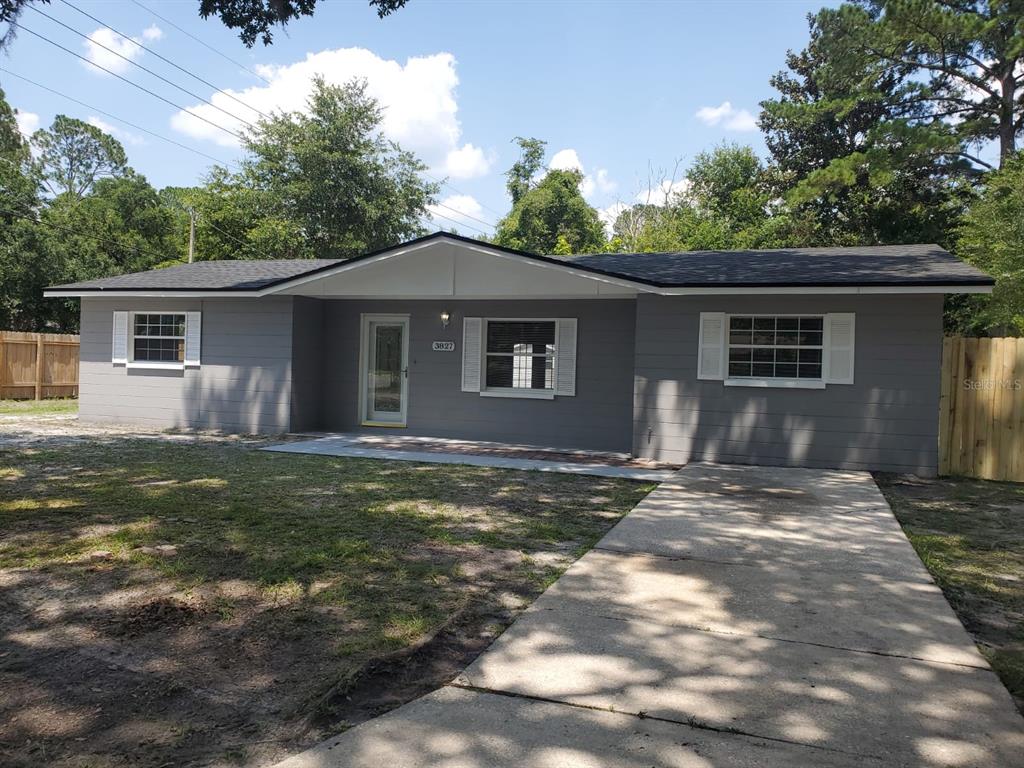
[[79, 297, 293, 433]]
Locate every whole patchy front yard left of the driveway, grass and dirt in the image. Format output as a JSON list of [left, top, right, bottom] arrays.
[[0, 438, 652, 766]]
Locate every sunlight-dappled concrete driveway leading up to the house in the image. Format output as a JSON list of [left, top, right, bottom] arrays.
[[282, 465, 1024, 768]]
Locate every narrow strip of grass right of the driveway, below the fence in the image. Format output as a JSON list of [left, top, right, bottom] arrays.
[[877, 474, 1024, 712]]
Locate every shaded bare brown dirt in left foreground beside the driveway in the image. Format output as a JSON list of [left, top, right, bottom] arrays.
[[0, 548, 534, 768]]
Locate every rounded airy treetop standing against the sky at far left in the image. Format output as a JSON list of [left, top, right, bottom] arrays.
[[32, 115, 128, 198]]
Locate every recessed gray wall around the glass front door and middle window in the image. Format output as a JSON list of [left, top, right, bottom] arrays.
[[322, 299, 636, 452]]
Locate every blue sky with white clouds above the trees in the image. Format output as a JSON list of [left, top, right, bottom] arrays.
[[0, 0, 822, 236]]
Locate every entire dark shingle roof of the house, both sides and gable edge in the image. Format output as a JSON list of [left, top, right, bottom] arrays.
[[47, 232, 993, 293]]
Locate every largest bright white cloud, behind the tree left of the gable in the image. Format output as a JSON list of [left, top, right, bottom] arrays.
[[171, 48, 493, 178]]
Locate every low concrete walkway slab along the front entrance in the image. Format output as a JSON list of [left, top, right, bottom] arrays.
[[262, 435, 675, 482]]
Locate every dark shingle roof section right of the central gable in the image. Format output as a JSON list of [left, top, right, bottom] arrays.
[[568, 245, 992, 288]]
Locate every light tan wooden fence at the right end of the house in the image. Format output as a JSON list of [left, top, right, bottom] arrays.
[[939, 337, 1024, 482]]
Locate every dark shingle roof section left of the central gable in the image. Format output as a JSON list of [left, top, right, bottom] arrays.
[[46, 259, 338, 291]]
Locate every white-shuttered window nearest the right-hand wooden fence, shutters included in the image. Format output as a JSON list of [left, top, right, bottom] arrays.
[[697, 312, 856, 389]]
